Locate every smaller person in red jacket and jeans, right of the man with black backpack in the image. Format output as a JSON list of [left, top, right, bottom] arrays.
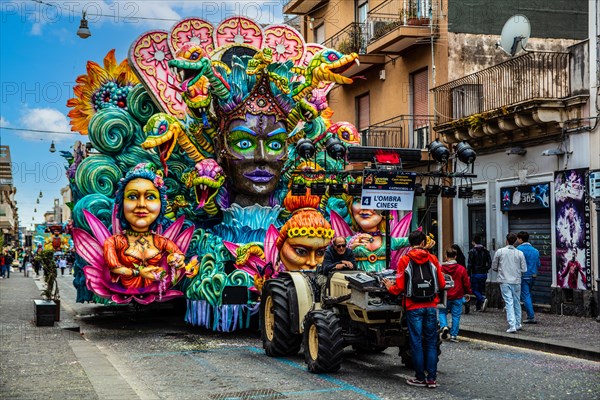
[[439, 247, 471, 342]]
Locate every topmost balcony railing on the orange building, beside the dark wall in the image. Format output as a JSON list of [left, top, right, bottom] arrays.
[[367, 0, 433, 42]]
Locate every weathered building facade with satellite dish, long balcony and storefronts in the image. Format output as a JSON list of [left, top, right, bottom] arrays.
[[432, 1, 599, 315]]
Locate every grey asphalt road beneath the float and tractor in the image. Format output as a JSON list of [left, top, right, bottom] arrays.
[[61, 278, 600, 400]]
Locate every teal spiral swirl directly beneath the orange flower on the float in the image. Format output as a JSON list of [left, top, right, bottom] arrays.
[[88, 108, 144, 154]]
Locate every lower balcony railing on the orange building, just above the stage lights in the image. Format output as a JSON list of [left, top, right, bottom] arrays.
[[362, 115, 433, 149]]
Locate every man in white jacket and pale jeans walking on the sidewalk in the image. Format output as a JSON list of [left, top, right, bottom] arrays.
[[492, 233, 527, 333]]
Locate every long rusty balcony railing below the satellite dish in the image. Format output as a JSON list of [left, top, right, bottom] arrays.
[[432, 52, 570, 125]]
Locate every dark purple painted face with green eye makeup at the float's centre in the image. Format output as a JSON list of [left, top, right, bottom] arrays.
[[225, 114, 287, 196]]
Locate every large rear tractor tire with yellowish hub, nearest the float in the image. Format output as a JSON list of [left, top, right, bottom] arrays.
[[260, 278, 302, 357]]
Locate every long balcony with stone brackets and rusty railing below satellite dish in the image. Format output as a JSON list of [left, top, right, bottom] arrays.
[[432, 52, 588, 148]]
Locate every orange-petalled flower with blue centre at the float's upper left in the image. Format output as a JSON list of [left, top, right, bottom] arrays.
[[67, 49, 139, 135]]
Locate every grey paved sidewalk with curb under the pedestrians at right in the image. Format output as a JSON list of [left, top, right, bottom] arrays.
[[459, 308, 600, 361]]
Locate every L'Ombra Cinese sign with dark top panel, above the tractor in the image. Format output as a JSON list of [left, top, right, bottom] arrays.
[[361, 169, 417, 211]]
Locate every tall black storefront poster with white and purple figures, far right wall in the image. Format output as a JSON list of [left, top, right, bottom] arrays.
[[554, 169, 592, 290]]
